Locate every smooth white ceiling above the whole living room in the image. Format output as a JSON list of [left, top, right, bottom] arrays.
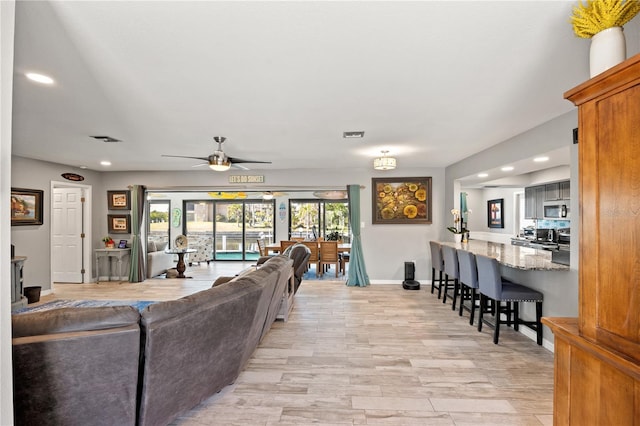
[[13, 1, 637, 175]]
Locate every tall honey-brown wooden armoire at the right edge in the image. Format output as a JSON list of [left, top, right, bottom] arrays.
[[544, 55, 640, 426]]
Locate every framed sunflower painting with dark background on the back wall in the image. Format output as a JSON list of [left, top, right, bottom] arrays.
[[371, 177, 432, 225]]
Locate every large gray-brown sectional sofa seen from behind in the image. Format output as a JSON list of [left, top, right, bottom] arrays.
[[12, 256, 293, 426]]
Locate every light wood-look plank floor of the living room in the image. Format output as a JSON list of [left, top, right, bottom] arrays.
[[47, 266, 553, 426]]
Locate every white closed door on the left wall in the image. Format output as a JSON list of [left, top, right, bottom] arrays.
[[51, 188, 83, 283]]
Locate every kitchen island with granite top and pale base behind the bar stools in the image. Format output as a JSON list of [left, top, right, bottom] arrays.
[[440, 236, 578, 351]]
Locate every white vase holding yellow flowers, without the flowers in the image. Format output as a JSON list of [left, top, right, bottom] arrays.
[[589, 27, 627, 77]]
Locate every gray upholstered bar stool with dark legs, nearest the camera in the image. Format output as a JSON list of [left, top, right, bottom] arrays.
[[478, 254, 544, 345]]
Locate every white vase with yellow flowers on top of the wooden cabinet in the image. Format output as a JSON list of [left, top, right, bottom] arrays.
[[571, 0, 640, 77]]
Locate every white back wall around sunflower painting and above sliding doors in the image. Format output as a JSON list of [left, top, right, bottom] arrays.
[[104, 168, 449, 284]]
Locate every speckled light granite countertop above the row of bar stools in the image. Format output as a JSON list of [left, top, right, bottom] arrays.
[[440, 240, 569, 271]]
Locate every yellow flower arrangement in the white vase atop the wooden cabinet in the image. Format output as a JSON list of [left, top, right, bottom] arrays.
[[571, 0, 640, 38]]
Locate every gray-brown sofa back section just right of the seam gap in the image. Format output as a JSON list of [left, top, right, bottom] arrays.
[[139, 280, 263, 426]]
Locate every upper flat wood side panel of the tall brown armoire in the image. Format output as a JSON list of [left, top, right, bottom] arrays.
[[596, 82, 640, 359]]
